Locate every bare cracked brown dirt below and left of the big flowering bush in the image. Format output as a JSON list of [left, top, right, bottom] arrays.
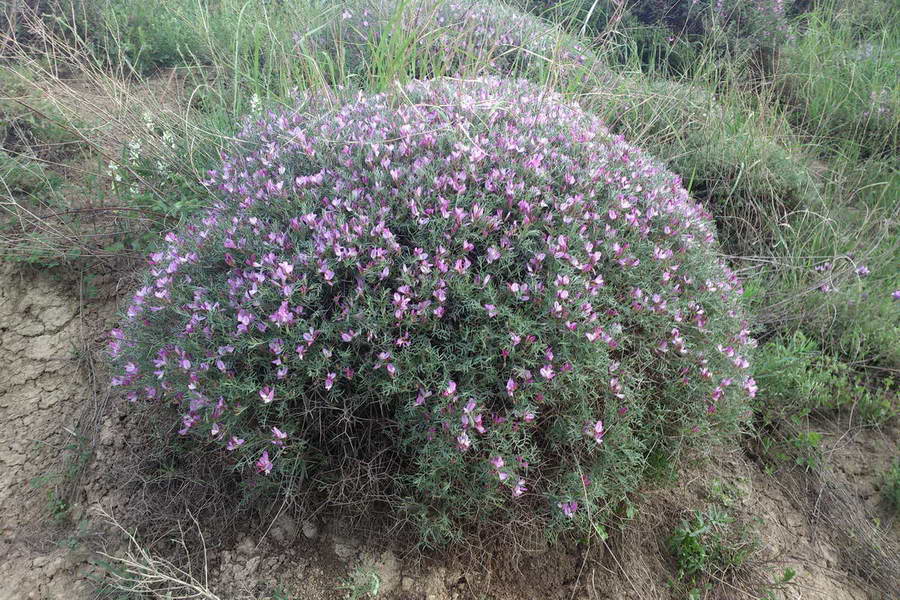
[[0, 266, 898, 600]]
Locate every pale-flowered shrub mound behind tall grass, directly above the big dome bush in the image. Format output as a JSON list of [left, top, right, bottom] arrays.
[[295, 0, 612, 87]]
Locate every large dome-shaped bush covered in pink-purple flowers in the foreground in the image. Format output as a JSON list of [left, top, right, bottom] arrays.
[[112, 79, 755, 540]]
